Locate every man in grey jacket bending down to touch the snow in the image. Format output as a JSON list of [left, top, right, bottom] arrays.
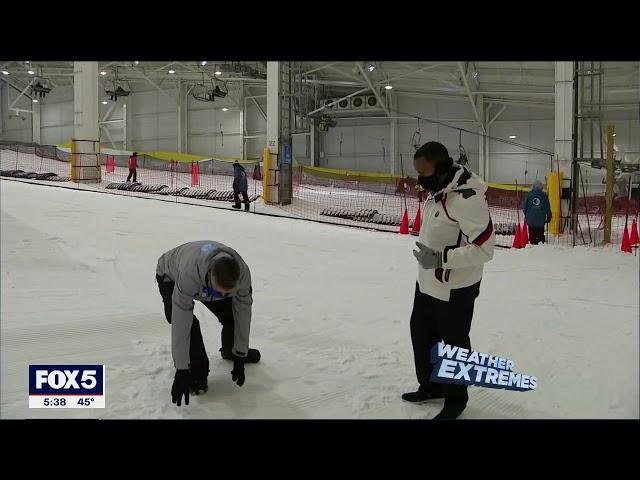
[[156, 241, 260, 406]]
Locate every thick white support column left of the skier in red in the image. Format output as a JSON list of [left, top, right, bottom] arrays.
[[71, 62, 100, 183]]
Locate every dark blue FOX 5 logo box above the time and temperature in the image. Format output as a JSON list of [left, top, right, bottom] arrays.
[[29, 365, 104, 396]]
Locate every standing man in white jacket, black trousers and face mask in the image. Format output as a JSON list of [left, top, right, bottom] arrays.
[[402, 142, 495, 419]]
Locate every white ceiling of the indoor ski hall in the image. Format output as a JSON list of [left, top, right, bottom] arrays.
[[0, 61, 640, 109]]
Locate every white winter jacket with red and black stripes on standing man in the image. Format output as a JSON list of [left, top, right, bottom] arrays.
[[418, 165, 495, 301]]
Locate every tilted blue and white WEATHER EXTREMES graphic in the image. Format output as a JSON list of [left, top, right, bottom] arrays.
[[431, 342, 538, 392]]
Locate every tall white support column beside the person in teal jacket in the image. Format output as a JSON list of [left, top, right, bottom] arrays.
[[554, 62, 574, 232]]
